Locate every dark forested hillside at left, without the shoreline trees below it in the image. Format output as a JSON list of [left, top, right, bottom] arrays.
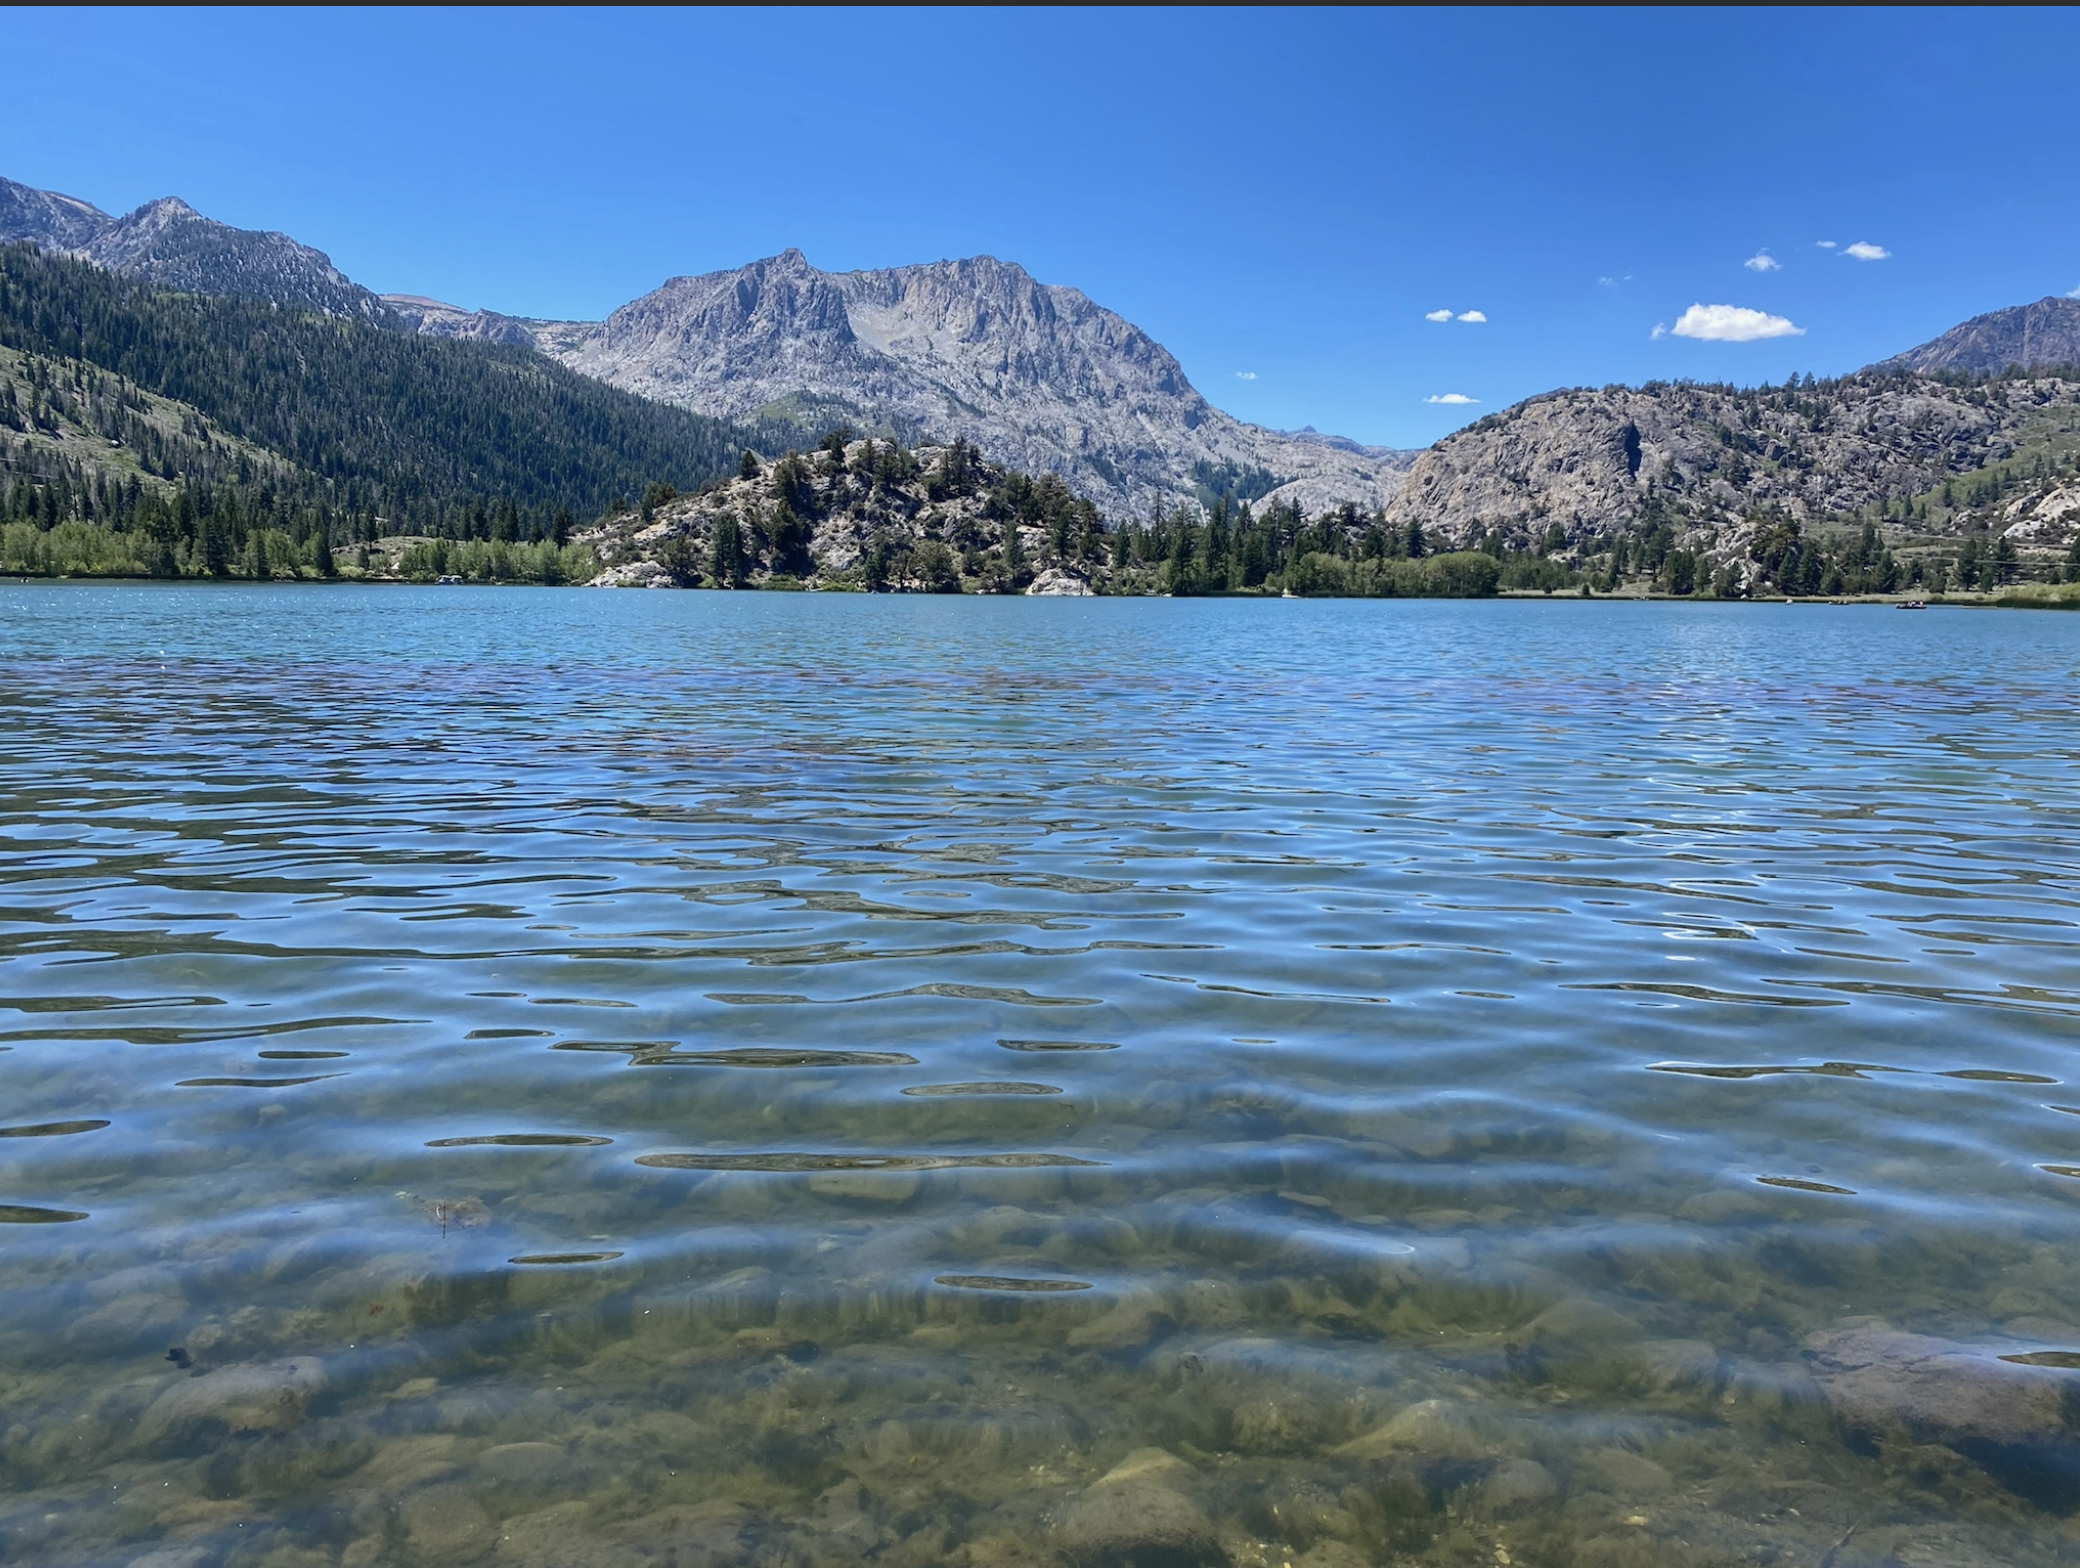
[[0, 245, 765, 557]]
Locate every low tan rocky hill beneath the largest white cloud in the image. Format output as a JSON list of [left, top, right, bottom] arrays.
[[1385, 372, 2080, 551]]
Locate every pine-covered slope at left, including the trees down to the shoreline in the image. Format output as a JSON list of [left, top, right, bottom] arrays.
[[0, 245, 755, 580]]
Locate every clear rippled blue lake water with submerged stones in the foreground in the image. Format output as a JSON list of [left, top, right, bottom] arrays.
[[0, 584, 2080, 1568]]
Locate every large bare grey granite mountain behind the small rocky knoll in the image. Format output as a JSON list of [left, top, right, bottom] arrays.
[[413, 250, 1412, 516]]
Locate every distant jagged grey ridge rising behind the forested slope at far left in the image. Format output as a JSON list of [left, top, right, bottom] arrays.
[[0, 179, 393, 324]]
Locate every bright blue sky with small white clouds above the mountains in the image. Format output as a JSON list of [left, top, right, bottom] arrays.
[[0, 10, 2080, 445]]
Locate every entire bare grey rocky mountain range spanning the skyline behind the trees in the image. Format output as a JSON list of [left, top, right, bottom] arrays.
[[0, 181, 2080, 545]]
